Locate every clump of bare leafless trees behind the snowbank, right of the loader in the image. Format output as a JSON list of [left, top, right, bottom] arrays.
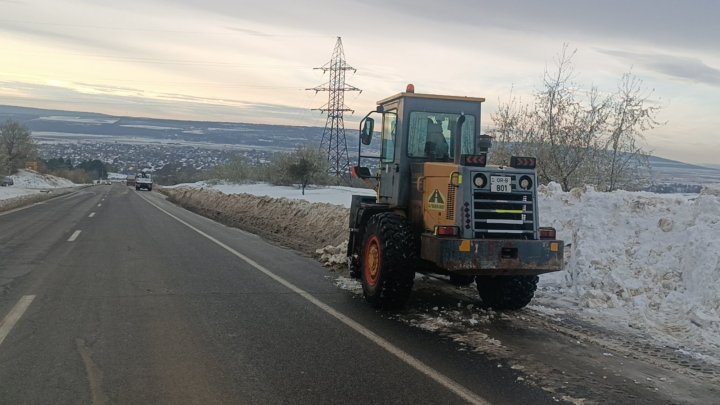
[[491, 44, 659, 191]]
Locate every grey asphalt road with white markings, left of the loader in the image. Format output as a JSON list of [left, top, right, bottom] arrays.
[[0, 185, 556, 404]]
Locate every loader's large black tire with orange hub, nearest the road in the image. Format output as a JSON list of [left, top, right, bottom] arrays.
[[360, 212, 416, 309]]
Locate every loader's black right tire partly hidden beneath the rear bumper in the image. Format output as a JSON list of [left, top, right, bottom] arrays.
[[475, 276, 540, 310]]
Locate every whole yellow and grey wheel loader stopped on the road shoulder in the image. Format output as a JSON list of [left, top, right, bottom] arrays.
[[347, 85, 563, 309]]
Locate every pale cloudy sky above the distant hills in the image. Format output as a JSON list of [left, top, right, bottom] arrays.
[[0, 0, 720, 164]]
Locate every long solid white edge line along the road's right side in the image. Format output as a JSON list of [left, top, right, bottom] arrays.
[[143, 197, 490, 405]]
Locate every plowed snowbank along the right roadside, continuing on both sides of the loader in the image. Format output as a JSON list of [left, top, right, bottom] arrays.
[[166, 184, 720, 355]]
